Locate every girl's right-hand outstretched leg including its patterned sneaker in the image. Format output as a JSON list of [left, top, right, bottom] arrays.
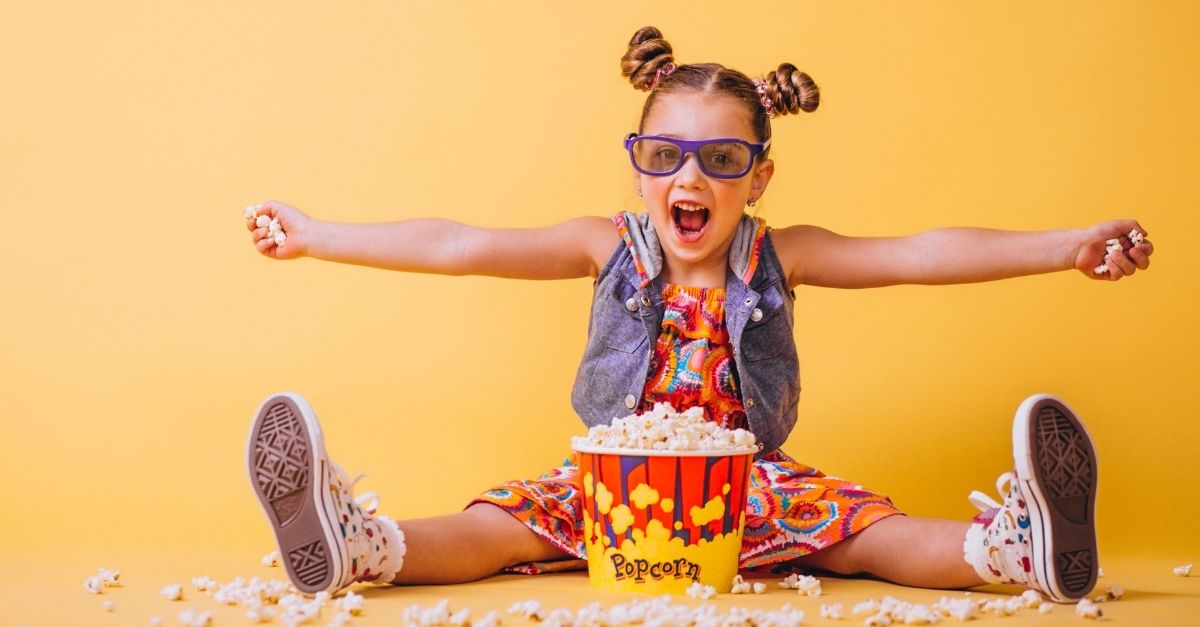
[[787, 394, 1097, 603]]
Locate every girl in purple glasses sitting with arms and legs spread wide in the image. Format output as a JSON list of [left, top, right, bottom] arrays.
[[247, 28, 1153, 602]]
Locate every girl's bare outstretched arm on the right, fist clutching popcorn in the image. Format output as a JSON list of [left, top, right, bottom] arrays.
[[772, 220, 1154, 287]]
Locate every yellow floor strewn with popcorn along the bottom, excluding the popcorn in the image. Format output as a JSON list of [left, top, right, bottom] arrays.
[[0, 549, 1200, 626]]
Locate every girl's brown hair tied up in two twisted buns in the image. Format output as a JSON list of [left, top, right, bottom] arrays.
[[620, 26, 821, 156]]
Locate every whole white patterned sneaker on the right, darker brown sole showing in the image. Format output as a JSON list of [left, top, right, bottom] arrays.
[[962, 394, 1097, 603]]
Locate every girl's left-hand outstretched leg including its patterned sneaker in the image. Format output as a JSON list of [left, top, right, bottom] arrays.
[[246, 393, 568, 593]]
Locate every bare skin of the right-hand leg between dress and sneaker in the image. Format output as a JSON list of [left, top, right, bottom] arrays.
[[800, 515, 984, 589]]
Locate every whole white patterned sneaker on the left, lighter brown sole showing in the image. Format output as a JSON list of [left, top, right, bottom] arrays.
[[246, 392, 404, 593]]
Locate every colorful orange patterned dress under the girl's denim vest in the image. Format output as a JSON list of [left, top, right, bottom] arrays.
[[472, 217, 900, 573]]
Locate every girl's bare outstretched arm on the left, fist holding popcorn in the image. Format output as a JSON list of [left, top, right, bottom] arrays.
[[246, 201, 618, 279]]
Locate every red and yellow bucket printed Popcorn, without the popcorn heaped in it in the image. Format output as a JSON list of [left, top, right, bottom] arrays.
[[575, 444, 757, 595]]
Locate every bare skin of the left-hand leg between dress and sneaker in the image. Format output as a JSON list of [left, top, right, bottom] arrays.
[[392, 503, 571, 584]]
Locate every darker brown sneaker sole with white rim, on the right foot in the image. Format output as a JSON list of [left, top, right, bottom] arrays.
[[1013, 394, 1098, 602]]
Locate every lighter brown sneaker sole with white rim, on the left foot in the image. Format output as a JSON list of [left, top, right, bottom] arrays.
[[246, 393, 348, 593]]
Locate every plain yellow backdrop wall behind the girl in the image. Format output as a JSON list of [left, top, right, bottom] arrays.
[[0, 1, 1200, 614]]
